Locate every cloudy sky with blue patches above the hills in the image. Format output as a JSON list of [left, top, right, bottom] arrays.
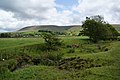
[[0, 0, 120, 32]]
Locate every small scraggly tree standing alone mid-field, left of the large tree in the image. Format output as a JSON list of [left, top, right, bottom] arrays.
[[42, 33, 62, 51]]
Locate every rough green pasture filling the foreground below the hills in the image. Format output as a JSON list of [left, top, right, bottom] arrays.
[[0, 36, 120, 80]]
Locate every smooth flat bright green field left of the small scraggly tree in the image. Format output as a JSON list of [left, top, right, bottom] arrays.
[[0, 38, 43, 49]]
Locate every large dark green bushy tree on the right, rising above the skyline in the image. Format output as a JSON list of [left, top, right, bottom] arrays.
[[81, 15, 118, 42]]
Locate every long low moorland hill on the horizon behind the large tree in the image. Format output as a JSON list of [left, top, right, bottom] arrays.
[[18, 24, 120, 32]]
